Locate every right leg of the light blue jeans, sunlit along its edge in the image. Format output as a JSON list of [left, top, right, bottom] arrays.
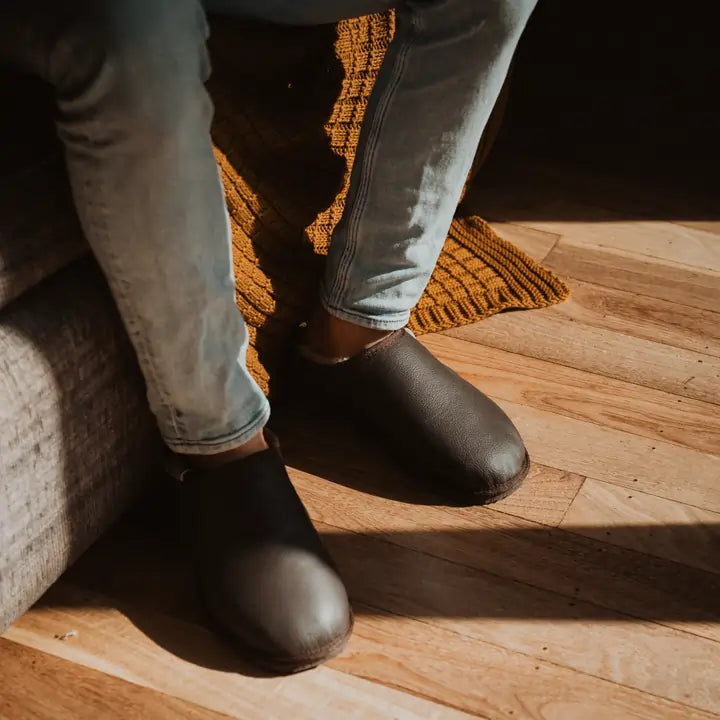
[[322, 0, 536, 329]]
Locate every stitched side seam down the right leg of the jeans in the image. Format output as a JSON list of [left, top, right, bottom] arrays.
[[326, 6, 419, 304]]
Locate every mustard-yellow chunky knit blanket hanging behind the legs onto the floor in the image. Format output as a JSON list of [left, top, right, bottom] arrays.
[[211, 12, 569, 392]]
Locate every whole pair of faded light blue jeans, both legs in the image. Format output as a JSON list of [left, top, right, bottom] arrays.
[[0, 0, 536, 454]]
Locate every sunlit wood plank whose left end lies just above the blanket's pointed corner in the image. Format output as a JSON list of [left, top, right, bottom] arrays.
[[543, 239, 720, 311]]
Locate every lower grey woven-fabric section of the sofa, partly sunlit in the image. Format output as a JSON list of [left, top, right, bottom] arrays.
[[0, 260, 159, 631]]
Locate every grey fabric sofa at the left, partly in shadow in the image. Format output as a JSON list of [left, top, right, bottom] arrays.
[[0, 71, 159, 631]]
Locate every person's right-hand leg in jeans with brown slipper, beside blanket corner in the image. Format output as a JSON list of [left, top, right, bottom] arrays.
[[298, 0, 535, 504]]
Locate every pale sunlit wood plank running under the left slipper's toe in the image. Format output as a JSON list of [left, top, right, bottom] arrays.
[[5, 588, 469, 720]]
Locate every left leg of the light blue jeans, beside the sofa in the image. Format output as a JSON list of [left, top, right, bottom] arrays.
[[6, 0, 269, 454]]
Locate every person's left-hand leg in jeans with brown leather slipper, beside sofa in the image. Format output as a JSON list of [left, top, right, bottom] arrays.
[[0, 0, 352, 672]]
